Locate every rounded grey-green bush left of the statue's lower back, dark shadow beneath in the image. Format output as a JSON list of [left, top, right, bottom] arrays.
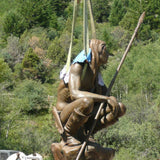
[[14, 80, 48, 112]]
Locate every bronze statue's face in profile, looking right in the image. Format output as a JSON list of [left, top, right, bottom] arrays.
[[98, 42, 109, 65]]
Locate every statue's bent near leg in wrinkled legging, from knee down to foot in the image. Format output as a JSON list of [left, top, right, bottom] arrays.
[[61, 98, 94, 145]]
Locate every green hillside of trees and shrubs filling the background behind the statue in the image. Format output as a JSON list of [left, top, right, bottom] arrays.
[[0, 0, 160, 160]]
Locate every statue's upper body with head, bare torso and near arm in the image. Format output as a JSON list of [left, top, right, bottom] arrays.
[[56, 39, 109, 110]]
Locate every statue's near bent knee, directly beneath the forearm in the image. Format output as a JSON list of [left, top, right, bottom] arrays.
[[79, 98, 94, 115]]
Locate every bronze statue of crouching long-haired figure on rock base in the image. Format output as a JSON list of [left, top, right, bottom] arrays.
[[52, 39, 126, 160]]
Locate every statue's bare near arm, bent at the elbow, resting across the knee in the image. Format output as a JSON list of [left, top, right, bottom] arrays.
[[69, 64, 109, 102]]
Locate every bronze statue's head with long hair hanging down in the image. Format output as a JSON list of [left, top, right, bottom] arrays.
[[90, 39, 109, 66]]
